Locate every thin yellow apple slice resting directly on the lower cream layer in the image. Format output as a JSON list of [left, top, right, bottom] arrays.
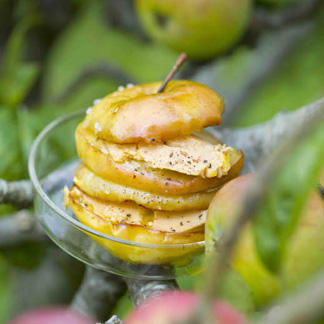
[[73, 163, 216, 211]]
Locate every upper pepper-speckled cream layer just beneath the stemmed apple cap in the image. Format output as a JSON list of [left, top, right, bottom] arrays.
[[76, 123, 237, 178]]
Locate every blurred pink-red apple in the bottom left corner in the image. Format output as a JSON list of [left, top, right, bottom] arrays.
[[8, 306, 95, 324]]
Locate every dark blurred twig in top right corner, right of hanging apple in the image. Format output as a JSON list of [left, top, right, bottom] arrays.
[[251, 0, 323, 31]]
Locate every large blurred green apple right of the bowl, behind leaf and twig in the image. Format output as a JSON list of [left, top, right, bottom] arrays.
[[206, 175, 324, 307]]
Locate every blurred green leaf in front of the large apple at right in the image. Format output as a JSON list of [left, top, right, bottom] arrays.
[[253, 124, 324, 272]]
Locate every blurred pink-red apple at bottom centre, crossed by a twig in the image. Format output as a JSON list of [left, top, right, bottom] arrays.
[[124, 290, 246, 324]]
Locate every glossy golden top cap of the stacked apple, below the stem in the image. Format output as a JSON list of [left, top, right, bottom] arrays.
[[85, 80, 224, 143]]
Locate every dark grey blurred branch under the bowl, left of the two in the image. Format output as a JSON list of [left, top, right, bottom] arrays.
[[71, 267, 126, 323]]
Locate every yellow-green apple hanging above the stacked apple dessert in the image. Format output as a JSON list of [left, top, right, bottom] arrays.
[[136, 0, 252, 60]]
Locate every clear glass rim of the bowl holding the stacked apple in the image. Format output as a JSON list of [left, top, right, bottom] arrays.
[[28, 110, 205, 249]]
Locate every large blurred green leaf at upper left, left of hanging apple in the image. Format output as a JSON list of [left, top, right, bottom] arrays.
[[44, 1, 177, 101]]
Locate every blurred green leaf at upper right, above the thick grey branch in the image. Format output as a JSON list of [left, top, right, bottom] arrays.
[[235, 10, 324, 126]]
